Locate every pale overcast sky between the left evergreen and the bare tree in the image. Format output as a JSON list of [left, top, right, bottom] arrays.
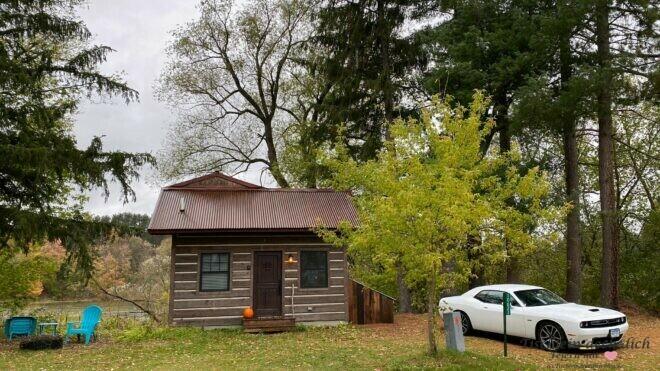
[[75, 0, 251, 215]]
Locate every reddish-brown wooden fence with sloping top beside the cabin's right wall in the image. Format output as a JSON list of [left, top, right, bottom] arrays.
[[348, 280, 394, 325]]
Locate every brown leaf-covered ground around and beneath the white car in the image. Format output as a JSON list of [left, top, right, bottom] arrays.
[[361, 310, 660, 370]]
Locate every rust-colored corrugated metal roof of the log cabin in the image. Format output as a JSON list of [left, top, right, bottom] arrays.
[[148, 174, 357, 234]]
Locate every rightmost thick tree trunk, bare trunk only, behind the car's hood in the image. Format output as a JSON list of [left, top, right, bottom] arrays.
[[595, 0, 619, 308]]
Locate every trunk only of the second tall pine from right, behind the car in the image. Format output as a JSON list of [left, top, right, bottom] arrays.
[[559, 13, 582, 303]]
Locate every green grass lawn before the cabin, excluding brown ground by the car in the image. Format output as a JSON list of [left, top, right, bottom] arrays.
[[0, 318, 531, 370]]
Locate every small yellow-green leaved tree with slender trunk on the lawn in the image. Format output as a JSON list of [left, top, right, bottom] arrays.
[[320, 92, 565, 354]]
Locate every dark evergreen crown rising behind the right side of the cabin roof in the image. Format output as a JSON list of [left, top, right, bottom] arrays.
[[316, 0, 431, 160]]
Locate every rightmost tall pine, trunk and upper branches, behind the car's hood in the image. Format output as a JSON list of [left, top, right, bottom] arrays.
[[586, 0, 660, 308]]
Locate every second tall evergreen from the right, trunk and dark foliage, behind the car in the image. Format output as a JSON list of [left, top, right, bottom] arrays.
[[513, 0, 591, 302]]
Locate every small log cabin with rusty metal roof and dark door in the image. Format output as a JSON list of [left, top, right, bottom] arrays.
[[148, 172, 357, 327]]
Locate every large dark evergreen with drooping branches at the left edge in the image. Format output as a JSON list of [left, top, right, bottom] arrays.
[[0, 0, 152, 272]]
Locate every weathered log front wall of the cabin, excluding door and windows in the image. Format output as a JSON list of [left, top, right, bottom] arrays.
[[169, 233, 348, 326]]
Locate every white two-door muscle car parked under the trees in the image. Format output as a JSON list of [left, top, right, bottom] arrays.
[[440, 284, 628, 351]]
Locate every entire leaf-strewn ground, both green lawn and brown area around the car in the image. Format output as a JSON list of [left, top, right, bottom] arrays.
[[0, 313, 660, 370]]
